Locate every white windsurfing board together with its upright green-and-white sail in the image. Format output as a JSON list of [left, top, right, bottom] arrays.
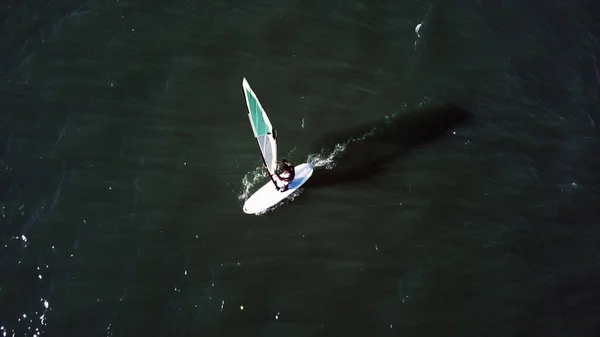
[[242, 78, 313, 214]]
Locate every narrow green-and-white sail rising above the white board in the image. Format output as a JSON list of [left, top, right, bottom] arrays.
[[242, 78, 277, 185]]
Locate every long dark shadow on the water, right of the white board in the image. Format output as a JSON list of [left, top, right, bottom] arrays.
[[306, 105, 472, 187]]
